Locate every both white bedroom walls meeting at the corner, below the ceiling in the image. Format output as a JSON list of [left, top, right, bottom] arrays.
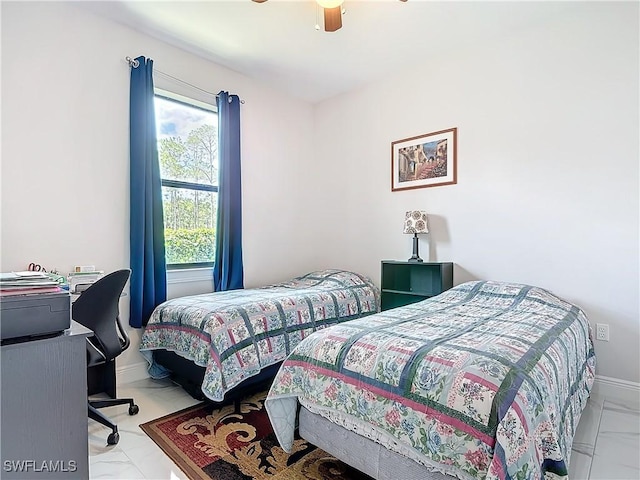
[[0, 2, 640, 382]]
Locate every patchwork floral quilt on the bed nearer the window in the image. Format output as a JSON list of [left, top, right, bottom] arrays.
[[140, 270, 380, 401]]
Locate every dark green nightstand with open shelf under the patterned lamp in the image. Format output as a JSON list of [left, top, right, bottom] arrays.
[[381, 260, 453, 310]]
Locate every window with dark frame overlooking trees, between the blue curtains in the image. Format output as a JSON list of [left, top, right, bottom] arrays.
[[155, 92, 218, 269]]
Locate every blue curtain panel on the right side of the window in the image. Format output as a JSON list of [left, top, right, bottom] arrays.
[[213, 92, 244, 292]]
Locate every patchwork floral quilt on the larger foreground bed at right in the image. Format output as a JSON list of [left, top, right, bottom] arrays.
[[265, 281, 595, 479]]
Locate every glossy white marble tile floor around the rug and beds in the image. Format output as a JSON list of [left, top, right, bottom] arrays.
[[89, 379, 640, 480]]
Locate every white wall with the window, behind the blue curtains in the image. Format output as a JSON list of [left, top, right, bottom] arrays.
[[0, 2, 313, 367]]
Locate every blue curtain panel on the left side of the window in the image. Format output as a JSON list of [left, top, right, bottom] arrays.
[[129, 57, 167, 328]]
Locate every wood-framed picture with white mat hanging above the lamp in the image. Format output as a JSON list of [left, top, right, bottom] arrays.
[[391, 128, 458, 192]]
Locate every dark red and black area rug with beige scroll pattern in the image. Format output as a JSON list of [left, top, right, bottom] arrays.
[[140, 392, 370, 480]]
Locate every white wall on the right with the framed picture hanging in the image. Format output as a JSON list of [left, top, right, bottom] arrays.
[[311, 2, 640, 382]]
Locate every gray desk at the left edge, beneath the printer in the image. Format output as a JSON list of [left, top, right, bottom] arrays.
[[0, 321, 92, 479]]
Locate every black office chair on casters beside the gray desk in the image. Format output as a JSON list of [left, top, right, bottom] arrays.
[[71, 270, 139, 445]]
